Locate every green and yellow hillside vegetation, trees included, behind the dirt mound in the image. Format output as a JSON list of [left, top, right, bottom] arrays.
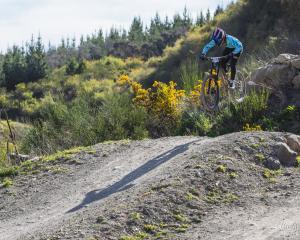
[[0, 0, 300, 174]]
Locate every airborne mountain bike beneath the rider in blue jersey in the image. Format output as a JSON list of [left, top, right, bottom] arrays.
[[201, 56, 246, 111]]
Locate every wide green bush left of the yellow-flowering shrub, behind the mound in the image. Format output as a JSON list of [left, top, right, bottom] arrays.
[[22, 94, 148, 154]]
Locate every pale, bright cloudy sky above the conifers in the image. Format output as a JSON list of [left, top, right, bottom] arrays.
[[0, 0, 231, 51]]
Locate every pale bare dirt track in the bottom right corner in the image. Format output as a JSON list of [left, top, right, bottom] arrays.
[[180, 196, 300, 240]]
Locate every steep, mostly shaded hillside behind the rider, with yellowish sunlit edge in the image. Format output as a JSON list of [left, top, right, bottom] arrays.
[[144, 0, 300, 86]]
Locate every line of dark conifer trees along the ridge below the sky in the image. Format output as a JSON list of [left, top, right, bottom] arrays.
[[0, 6, 223, 90]]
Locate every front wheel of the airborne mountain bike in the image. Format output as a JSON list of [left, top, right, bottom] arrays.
[[201, 76, 220, 111]]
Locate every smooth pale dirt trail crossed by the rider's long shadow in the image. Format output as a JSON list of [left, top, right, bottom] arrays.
[[0, 137, 201, 240]]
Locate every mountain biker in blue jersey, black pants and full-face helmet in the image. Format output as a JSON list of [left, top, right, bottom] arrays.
[[200, 28, 243, 89]]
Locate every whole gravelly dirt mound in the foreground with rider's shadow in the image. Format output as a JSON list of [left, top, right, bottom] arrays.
[[0, 132, 300, 240]]
